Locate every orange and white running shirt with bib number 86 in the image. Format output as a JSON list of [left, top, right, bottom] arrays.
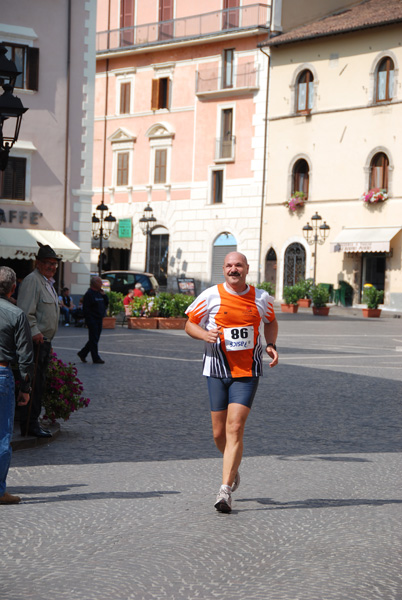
[[186, 283, 275, 378]]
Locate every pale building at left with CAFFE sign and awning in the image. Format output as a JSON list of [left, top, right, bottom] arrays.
[[0, 0, 96, 294]]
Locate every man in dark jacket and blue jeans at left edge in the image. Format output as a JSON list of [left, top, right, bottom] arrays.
[[0, 267, 33, 504]]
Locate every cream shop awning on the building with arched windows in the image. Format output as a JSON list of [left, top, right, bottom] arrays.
[[331, 226, 402, 252]]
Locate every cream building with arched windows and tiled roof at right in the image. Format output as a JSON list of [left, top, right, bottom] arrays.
[[262, 0, 402, 309]]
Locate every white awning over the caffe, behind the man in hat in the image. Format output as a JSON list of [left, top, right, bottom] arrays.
[[0, 226, 81, 262]]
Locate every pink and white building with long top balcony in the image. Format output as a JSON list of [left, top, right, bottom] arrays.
[[92, 0, 270, 292]]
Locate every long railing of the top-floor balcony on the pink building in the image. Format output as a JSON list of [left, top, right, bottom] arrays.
[[96, 4, 270, 53]]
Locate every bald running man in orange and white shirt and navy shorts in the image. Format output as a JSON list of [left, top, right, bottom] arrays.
[[186, 252, 278, 513]]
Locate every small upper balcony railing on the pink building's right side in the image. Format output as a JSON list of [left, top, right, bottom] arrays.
[[195, 61, 259, 94]]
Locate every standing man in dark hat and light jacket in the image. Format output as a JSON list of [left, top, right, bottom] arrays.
[[17, 242, 61, 437]]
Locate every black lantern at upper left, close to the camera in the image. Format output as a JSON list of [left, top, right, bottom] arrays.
[[0, 44, 28, 171]]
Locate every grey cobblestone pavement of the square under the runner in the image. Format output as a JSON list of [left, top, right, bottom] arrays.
[[0, 312, 402, 600]]
